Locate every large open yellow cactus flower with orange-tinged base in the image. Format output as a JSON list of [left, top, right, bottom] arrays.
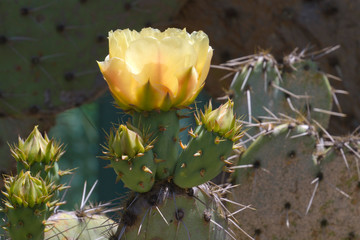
[[98, 28, 213, 111]]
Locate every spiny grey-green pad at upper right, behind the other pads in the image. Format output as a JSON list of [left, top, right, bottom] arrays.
[[223, 49, 343, 128]]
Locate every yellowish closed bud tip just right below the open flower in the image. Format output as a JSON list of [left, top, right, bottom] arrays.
[[196, 99, 242, 141]]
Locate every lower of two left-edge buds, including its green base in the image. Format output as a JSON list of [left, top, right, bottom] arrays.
[[3, 171, 60, 240]]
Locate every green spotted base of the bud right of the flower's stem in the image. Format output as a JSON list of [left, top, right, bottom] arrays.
[[173, 125, 233, 188]]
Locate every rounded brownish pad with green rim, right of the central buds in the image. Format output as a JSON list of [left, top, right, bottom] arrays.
[[233, 123, 321, 239]]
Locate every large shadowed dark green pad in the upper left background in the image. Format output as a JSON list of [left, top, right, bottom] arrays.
[[0, 0, 183, 117]]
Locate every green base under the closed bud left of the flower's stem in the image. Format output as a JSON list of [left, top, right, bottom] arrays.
[[110, 150, 156, 192]]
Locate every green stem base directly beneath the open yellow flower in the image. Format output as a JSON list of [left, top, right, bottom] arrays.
[[132, 111, 180, 180]]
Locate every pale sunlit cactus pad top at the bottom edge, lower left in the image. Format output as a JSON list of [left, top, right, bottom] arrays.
[[45, 211, 116, 240]]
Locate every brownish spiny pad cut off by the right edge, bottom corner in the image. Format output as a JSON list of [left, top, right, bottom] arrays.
[[302, 136, 360, 239]]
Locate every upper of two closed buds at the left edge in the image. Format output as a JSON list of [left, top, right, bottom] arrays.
[[10, 126, 64, 169]]
